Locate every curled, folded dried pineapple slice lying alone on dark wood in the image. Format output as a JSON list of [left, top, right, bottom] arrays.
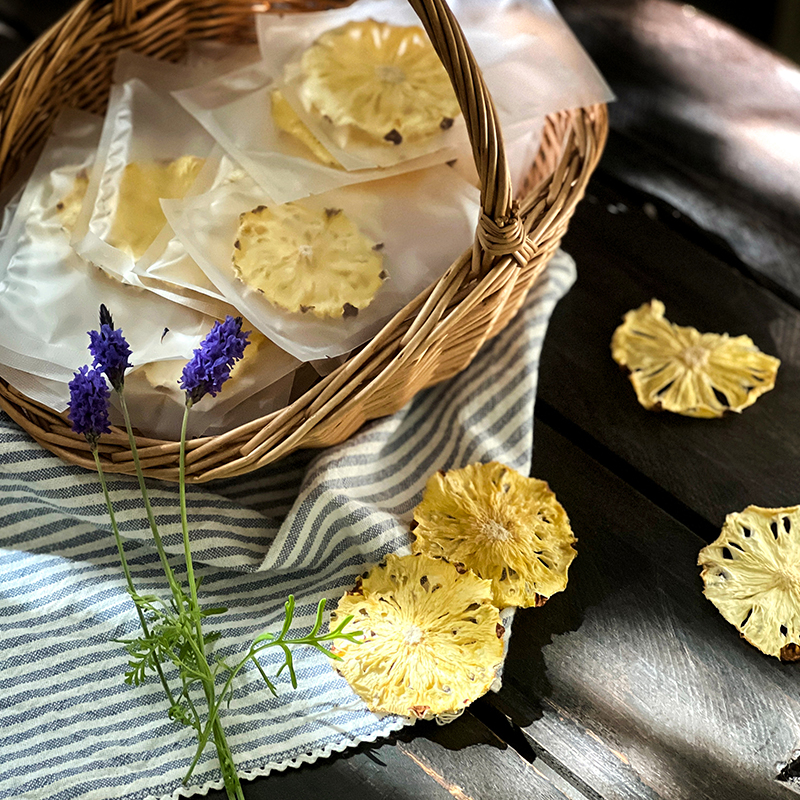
[[611, 300, 781, 418]]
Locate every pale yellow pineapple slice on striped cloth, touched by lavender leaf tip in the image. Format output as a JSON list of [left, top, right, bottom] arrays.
[[331, 555, 505, 719]]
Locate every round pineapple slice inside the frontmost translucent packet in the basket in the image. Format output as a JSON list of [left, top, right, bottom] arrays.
[[233, 203, 386, 318]]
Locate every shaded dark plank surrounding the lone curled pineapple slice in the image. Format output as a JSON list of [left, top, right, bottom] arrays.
[[539, 180, 800, 537]]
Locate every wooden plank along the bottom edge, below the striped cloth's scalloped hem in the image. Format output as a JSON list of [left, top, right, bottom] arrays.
[[199, 714, 576, 800]]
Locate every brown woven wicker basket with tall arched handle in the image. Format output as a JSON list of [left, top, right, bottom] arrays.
[[0, 0, 608, 482]]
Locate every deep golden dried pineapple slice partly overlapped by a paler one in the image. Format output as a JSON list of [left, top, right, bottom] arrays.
[[413, 461, 577, 608]]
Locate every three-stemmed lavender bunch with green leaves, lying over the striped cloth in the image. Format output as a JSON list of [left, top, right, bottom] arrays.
[[76, 306, 357, 800]]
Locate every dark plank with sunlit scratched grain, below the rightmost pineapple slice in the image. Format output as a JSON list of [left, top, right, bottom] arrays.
[[494, 423, 800, 800]]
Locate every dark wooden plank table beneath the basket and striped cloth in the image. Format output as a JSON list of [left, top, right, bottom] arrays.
[[0, 0, 800, 800]]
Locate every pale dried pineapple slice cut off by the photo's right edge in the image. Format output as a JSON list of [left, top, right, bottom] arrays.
[[697, 506, 800, 661]]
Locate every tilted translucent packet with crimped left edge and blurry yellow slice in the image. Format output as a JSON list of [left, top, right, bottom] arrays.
[[72, 53, 216, 306]]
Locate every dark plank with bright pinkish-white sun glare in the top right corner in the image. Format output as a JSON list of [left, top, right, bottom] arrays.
[[557, 0, 800, 304]]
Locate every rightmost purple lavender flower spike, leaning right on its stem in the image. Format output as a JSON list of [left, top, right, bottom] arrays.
[[180, 316, 250, 406]]
